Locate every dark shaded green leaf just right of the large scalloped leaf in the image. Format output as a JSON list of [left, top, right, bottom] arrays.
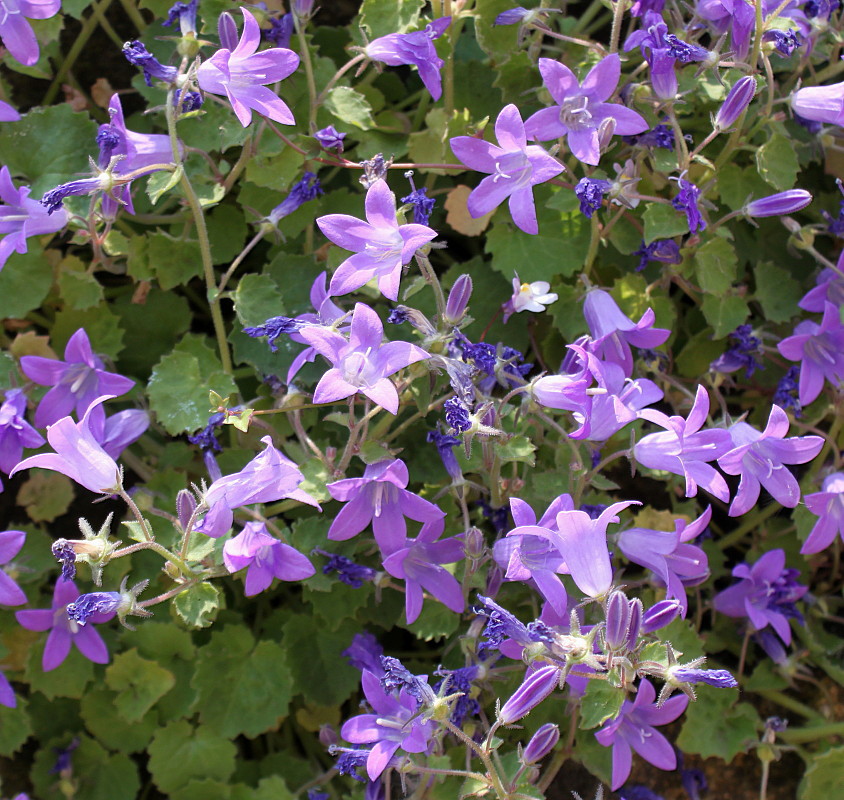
[[282, 616, 360, 706]]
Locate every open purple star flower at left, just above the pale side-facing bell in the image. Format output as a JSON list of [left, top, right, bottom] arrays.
[[21, 328, 135, 428]]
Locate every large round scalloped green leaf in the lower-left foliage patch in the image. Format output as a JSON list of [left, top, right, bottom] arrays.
[[191, 623, 294, 738]]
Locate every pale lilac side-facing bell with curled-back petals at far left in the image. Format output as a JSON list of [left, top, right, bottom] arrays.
[[9, 395, 122, 494]]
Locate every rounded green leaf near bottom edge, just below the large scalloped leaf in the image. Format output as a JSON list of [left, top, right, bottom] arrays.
[[147, 720, 237, 794]]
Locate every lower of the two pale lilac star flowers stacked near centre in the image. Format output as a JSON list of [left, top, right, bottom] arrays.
[[299, 303, 428, 414]]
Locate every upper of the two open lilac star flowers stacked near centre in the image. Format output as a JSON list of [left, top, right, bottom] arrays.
[[317, 181, 437, 301]]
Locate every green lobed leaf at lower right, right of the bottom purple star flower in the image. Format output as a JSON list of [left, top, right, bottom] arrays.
[[677, 686, 759, 761]]
